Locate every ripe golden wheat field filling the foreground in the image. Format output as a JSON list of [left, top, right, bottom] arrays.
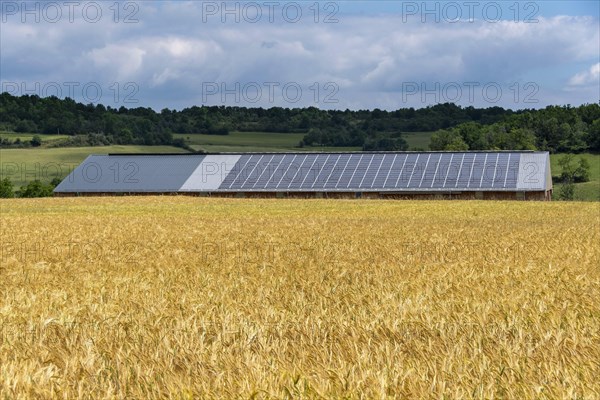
[[0, 197, 600, 399]]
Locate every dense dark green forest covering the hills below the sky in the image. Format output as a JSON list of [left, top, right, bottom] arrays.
[[0, 93, 600, 153]]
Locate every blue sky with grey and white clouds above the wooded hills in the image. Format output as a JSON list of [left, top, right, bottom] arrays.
[[0, 0, 600, 110]]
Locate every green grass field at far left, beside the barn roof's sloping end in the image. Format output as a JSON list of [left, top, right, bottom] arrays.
[[0, 146, 187, 188]]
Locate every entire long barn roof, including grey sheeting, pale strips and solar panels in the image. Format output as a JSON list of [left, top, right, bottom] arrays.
[[55, 151, 552, 193]]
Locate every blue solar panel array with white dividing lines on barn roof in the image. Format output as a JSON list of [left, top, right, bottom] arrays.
[[219, 153, 520, 191]]
